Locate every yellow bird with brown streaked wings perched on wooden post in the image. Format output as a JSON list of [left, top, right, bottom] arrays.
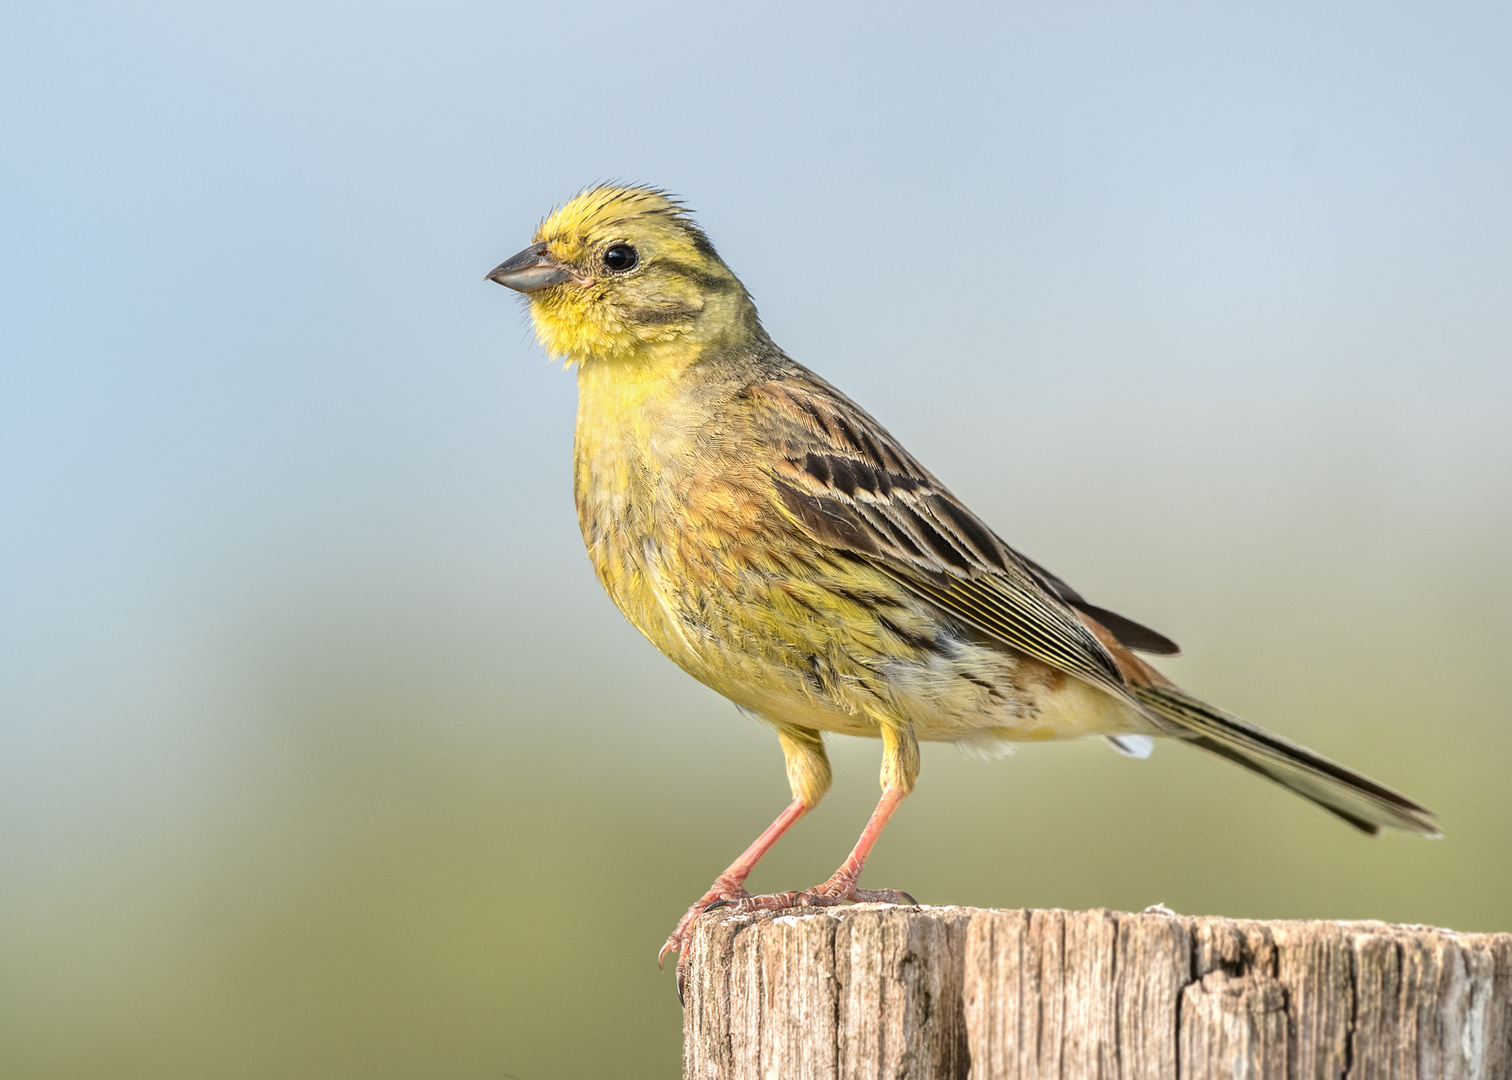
[[487, 183, 1441, 994]]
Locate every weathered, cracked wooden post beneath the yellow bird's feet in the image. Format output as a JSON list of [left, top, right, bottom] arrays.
[[683, 905, 1512, 1080]]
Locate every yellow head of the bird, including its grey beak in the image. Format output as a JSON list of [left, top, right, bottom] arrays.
[[488, 186, 761, 363]]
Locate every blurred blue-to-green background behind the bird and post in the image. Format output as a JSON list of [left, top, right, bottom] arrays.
[[0, 0, 1512, 1080]]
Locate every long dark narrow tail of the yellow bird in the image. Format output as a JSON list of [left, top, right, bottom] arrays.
[[1129, 684, 1442, 836]]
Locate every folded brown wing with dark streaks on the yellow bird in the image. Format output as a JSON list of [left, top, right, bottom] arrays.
[[747, 365, 1175, 696]]
